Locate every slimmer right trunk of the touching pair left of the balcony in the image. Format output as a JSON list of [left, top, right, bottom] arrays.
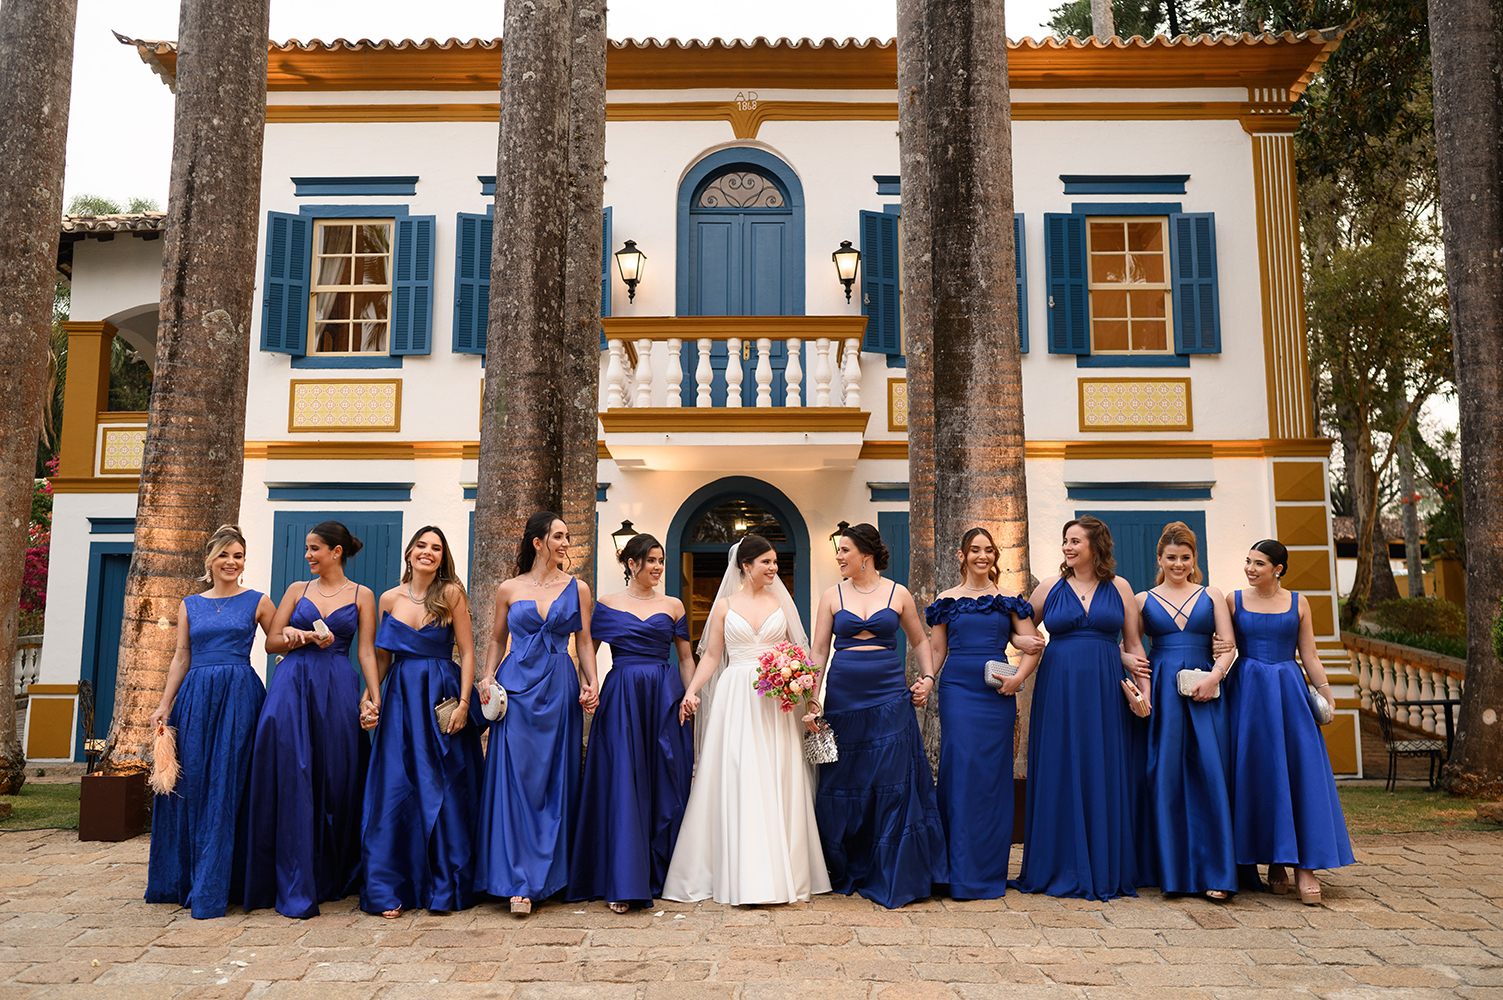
[[559, 0, 606, 586]]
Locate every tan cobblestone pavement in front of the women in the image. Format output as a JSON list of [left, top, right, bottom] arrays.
[[0, 832, 1503, 1000]]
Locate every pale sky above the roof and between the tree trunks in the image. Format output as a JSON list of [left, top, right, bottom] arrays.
[[63, 0, 1063, 208]]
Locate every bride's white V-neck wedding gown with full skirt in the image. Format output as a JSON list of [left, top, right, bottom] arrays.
[[663, 609, 830, 904]]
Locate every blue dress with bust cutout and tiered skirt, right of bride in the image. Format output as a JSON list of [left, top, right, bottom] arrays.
[[815, 583, 948, 910]]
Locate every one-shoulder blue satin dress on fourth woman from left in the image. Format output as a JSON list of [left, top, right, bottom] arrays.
[[472, 579, 585, 899]]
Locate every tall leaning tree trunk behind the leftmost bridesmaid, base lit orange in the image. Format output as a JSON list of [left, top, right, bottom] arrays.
[[105, 0, 269, 770]]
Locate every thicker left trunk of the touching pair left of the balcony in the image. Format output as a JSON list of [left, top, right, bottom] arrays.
[[470, 0, 579, 636]]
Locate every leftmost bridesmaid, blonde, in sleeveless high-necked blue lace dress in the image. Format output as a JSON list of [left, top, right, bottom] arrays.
[[146, 525, 277, 919]]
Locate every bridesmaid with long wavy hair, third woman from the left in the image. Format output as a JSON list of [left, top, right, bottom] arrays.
[[361, 525, 481, 919]]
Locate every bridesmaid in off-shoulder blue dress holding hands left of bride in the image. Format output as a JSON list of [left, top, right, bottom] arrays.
[[568, 534, 694, 913]]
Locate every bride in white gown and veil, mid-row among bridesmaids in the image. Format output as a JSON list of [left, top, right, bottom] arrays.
[[663, 535, 830, 904]]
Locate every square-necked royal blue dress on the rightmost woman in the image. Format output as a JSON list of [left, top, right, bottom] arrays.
[[1226, 591, 1354, 868]]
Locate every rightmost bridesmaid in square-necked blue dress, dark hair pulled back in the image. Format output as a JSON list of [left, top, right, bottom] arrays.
[[1226, 538, 1354, 905]]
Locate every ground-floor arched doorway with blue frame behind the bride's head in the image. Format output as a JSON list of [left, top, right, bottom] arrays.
[[663, 475, 809, 644]]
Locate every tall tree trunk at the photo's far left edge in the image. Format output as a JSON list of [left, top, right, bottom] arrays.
[[0, 0, 78, 795]]
